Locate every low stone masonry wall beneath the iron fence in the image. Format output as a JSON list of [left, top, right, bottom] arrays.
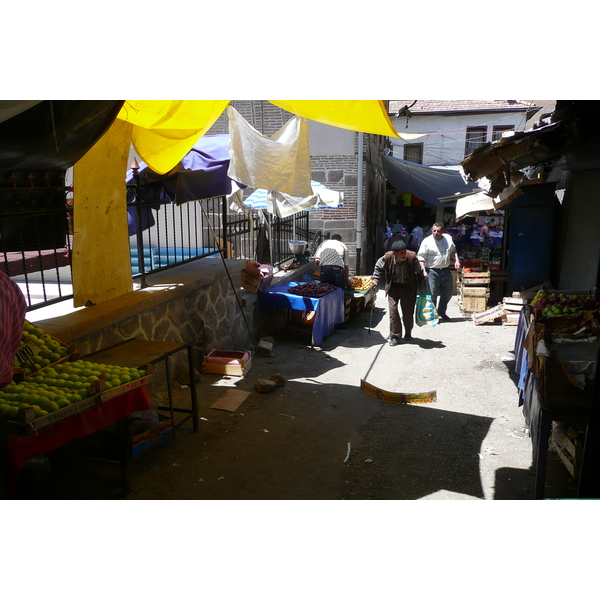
[[34, 259, 259, 401]]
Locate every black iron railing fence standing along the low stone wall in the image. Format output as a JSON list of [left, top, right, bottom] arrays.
[[0, 177, 314, 310]]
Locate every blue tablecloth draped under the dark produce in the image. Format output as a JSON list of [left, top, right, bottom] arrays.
[[258, 281, 344, 346]]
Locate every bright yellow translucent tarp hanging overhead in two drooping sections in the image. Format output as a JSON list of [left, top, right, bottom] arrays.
[[118, 100, 399, 175]]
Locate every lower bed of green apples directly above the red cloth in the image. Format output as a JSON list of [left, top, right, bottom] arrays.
[[0, 360, 146, 420]]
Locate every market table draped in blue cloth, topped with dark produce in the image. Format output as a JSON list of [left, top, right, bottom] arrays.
[[258, 281, 344, 346]]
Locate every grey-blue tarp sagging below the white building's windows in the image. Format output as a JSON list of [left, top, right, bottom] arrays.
[[381, 155, 477, 206]]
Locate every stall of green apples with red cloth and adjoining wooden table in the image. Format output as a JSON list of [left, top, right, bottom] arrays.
[[0, 321, 198, 497]]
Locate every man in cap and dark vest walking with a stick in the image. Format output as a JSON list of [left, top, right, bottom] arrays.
[[372, 241, 424, 346]]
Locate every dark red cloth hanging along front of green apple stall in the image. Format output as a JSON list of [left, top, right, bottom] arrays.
[[5, 386, 151, 498]]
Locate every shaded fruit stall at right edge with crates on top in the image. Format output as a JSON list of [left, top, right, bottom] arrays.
[[515, 290, 600, 499]]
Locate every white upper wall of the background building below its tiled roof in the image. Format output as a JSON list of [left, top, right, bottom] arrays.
[[390, 112, 526, 166]]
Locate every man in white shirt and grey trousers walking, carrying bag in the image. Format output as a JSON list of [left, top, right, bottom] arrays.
[[417, 221, 460, 321]]
